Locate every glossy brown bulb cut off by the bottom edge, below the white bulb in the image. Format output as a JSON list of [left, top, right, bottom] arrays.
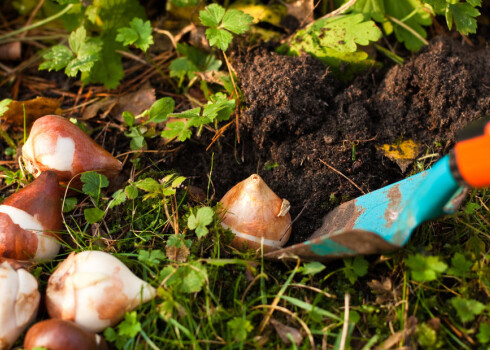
[[24, 319, 107, 350]]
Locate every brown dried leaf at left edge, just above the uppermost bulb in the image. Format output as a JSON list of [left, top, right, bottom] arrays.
[[0, 96, 63, 130]]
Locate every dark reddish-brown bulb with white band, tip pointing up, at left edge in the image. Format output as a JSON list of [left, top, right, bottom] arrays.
[[0, 171, 63, 261]]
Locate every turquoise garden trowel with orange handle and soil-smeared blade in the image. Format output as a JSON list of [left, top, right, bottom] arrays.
[[264, 117, 490, 261]]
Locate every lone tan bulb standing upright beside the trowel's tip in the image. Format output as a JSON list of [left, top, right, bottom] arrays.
[[220, 174, 291, 252]]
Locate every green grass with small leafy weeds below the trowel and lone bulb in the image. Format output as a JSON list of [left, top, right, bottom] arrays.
[[6, 157, 490, 349]]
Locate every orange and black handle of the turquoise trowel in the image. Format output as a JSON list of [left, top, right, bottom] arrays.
[[451, 122, 490, 188]]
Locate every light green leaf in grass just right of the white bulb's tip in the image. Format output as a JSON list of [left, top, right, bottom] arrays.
[[162, 261, 208, 293]]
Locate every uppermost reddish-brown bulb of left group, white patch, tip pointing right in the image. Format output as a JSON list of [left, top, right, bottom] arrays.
[[22, 115, 122, 187]]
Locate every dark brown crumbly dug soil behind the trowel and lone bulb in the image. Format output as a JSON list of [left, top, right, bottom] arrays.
[[168, 37, 490, 243]]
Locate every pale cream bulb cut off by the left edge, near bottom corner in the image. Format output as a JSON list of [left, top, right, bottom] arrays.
[[0, 261, 41, 350]]
